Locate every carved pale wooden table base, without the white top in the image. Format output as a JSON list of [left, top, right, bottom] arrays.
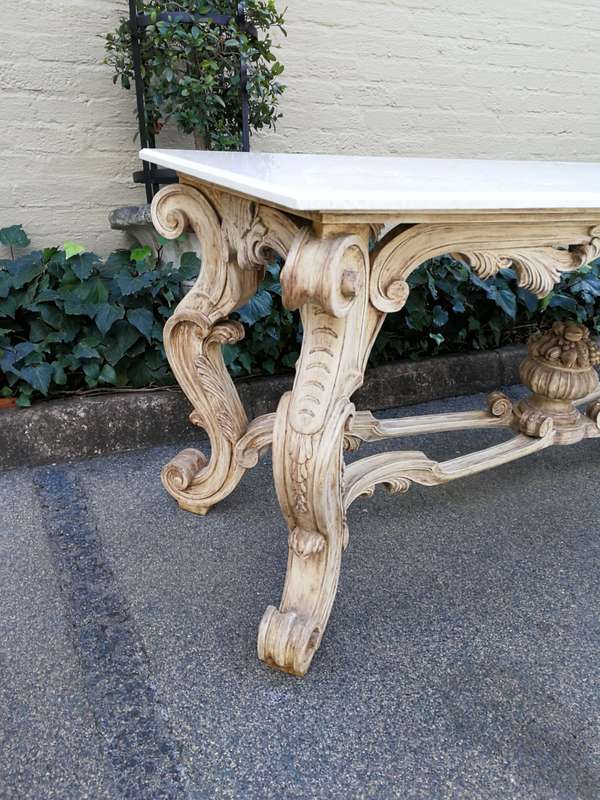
[[152, 176, 600, 675]]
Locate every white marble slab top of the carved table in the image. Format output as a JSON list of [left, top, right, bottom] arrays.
[[140, 149, 600, 212]]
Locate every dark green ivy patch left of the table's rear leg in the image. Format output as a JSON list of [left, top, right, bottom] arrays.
[[0, 226, 199, 406]]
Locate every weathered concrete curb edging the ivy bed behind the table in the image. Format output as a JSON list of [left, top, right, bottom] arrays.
[[0, 346, 526, 470]]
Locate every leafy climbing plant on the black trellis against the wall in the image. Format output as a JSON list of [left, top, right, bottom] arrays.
[[105, 0, 285, 150]]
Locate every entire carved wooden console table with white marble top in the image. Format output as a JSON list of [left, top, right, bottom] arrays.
[[140, 149, 600, 675]]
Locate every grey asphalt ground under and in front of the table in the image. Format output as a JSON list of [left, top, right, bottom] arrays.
[[0, 396, 600, 800]]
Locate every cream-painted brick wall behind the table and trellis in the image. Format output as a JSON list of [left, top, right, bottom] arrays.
[[0, 0, 600, 253]]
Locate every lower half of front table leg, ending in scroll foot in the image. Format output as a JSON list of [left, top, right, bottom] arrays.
[[257, 393, 353, 675]]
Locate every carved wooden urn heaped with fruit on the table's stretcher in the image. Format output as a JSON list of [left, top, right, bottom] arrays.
[[516, 322, 600, 438]]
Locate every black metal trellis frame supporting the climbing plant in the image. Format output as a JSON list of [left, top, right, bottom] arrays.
[[129, 0, 258, 203]]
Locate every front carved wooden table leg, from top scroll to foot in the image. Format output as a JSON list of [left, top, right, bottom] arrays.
[[258, 226, 382, 675]]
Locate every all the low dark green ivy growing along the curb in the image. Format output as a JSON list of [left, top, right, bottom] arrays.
[[0, 225, 600, 406]]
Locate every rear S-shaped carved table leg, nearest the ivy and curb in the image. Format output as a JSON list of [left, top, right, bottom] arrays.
[[152, 184, 297, 514]]
